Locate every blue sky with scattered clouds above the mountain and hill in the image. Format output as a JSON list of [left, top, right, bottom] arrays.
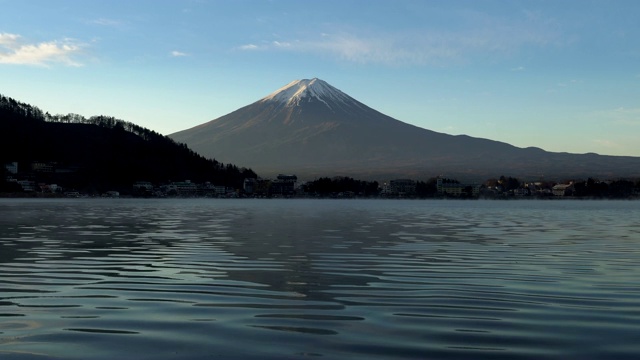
[[0, 0, 640, 156]]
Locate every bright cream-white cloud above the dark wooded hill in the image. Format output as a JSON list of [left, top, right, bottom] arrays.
[[0, 33, 83, 66]]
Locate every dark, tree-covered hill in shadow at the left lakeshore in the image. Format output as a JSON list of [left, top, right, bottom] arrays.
[[0, 95, 256, 193]]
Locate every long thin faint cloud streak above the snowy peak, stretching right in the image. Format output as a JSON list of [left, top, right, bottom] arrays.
[[236, 15, 559, 65]]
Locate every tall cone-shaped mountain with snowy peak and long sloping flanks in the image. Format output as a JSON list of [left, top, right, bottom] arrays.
[[169, 78, 640, 181]]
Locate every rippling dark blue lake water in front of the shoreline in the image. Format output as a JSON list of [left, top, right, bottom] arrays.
[[0, 199, 640, 360]]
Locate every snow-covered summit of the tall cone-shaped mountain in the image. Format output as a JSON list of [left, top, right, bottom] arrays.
[[260, 78, 354, 109]]
